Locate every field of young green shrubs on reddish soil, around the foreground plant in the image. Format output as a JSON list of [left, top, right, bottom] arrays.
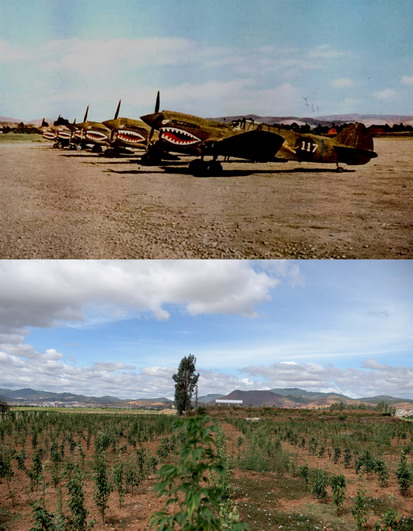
[[0, 407, 413, 531]]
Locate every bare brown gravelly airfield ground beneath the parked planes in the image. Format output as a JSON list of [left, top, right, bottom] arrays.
[[0, 138, 413, 259]]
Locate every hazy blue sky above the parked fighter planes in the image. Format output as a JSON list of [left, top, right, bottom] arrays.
[[0, 0, 413, 120]]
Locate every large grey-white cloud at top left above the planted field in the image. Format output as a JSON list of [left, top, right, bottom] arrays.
[[0, 260, 278, 334]]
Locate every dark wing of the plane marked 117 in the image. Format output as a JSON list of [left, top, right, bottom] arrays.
[[210, 130, 284, 162]]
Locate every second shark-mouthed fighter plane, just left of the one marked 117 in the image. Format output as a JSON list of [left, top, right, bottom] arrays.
[[103, 101, 150, 156]]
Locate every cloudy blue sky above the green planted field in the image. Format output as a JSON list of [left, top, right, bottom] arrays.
[[0, 260, 413, 398]]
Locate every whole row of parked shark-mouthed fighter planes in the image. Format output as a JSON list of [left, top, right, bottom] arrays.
[[43, 92, 377, 176]]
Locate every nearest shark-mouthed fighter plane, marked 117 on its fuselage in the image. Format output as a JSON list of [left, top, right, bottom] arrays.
[[141, 102, 377, 176]]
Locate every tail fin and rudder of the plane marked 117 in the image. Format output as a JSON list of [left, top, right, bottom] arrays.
[[334, 123, 377, 165]]
